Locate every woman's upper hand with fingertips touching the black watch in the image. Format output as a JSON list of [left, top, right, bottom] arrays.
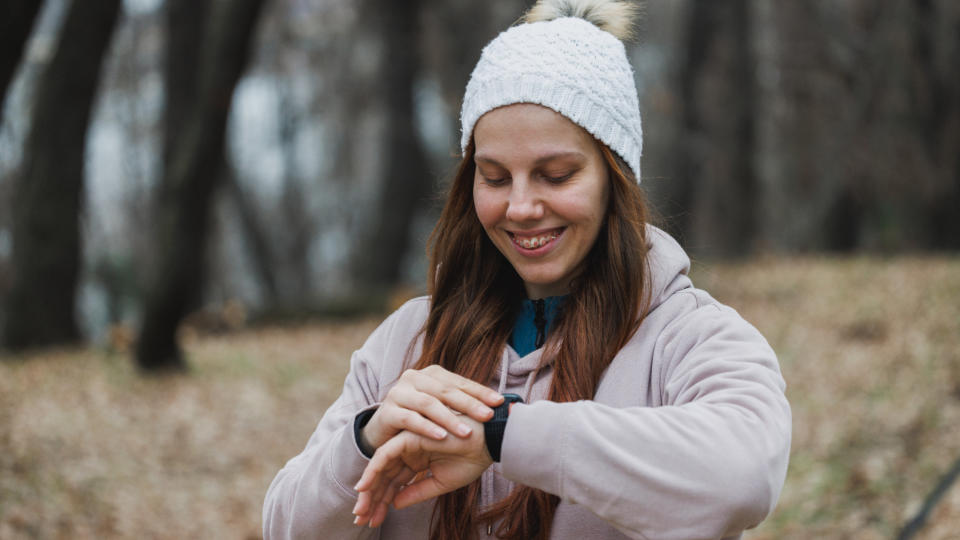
[[361, 365, 503, 450]]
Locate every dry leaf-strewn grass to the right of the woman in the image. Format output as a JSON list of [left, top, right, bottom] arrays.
[[695, 258, 960, 540]]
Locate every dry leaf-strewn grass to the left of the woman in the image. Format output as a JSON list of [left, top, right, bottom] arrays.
[[0, 321, 376, 539]]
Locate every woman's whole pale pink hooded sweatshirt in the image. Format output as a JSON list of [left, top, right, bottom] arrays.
[[263, 227, 791, 540]]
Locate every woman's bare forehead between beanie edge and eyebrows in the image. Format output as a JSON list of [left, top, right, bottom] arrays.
[[473, 103, 597, 157]]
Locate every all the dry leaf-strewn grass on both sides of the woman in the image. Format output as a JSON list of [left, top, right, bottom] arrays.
[[0, 258, 960, 540]]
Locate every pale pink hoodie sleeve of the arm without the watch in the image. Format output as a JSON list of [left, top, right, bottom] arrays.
[[263, 309, 420, 540]]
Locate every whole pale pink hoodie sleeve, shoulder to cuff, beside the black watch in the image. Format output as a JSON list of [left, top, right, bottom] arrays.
[[502, 294, 791, 540]]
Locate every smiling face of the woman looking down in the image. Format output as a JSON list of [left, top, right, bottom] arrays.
[[473, 103, 609, 299]]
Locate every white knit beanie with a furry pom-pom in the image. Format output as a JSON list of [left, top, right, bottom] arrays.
[[460, 0, 643, 182]]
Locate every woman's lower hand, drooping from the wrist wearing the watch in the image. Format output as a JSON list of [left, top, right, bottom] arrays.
[[353, 415, 493, 527]]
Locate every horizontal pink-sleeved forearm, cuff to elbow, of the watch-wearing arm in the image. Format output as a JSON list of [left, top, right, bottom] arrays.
[[502, 392, 789, 539]]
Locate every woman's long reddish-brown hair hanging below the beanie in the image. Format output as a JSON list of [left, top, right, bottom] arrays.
[[415, 142, 649, 540]]
